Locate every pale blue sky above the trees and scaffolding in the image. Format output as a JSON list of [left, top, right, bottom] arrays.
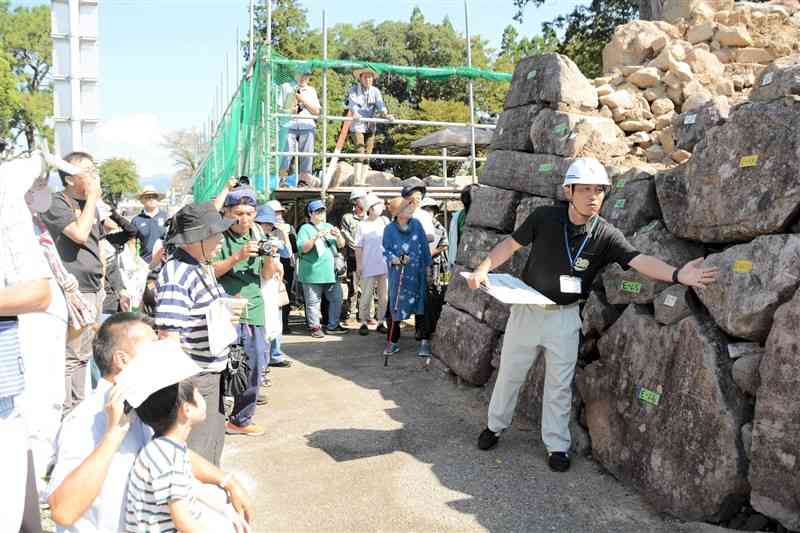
[[11, 0, 585, 183]]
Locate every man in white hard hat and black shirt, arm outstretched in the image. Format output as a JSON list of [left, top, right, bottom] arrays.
[[462, 158, 718, 472]]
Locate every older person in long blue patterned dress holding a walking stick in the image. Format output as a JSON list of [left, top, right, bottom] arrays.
[[383, 198, 431, 356]]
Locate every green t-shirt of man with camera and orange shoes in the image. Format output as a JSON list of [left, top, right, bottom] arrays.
[[214, 230, 265, 326]]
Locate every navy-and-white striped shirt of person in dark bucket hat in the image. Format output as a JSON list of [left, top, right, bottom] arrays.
[[156, 249, 228, 373]]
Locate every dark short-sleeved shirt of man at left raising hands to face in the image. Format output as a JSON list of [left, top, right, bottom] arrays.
[[42, 191, 103, 292]]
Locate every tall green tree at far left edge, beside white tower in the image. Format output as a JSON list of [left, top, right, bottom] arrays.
[[0, 2, 53, 148]]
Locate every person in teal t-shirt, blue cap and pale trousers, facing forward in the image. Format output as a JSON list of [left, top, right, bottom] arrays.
[[297, 200, 349, 339]]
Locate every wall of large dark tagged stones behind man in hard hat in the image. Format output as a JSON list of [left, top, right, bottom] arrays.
[[434, 21, 800, 530]]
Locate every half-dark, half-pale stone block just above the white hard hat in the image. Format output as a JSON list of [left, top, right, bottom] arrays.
[[531, 109, 628, 160]]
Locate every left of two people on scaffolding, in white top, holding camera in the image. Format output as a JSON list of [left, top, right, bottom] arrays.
[[279, 67, 321, 187]]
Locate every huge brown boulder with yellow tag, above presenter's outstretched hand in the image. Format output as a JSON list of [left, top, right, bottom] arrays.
[[656, 100, 800, 243]]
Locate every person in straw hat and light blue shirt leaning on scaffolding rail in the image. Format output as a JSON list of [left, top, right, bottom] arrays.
[[347, 67, 394, 185]]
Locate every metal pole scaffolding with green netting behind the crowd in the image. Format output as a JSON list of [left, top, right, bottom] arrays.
[[193, 0, 511, 205]]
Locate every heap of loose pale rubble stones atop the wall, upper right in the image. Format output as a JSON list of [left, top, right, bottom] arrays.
[[594, 0, 800, 165]]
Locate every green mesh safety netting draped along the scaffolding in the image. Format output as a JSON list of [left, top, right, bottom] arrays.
[[192, 50, 511, 202]]
